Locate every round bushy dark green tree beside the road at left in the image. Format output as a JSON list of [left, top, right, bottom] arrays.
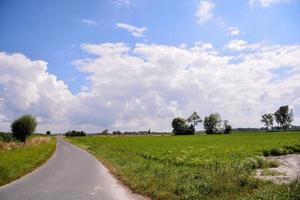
[[11, 115, 37, 142]]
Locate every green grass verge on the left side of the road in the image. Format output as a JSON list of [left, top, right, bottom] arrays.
[[0, 136, 56, 185]]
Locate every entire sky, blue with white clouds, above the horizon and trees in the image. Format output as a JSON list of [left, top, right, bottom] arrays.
[[0, 0, 300, 132]]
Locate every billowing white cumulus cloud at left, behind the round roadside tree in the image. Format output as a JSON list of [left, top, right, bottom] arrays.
[[0, 53, 72, 132]]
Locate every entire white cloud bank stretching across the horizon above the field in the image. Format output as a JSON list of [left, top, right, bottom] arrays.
[[0, 41, 300, 131]]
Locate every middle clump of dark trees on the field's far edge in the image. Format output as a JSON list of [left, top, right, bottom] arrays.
[[172, 112, 232, 135]]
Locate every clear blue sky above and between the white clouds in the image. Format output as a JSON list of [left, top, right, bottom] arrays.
[[0, 0, 300, 93]]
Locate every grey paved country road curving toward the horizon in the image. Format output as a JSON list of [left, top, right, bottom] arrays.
[[0, 139, 144, 200]]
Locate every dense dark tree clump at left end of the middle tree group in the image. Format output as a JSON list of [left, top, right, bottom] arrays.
[[172, 117, 195, 135]]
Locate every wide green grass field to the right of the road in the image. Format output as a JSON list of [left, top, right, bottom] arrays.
[[68, 132, 300, 200]]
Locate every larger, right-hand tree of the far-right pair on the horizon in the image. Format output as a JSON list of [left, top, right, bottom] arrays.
[[274, 106, 294, 130]]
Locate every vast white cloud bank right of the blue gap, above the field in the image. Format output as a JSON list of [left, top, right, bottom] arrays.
[[72, 41, 300, 130]]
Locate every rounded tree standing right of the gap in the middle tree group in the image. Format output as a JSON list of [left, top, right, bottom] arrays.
[[203, 113, 222, 134]]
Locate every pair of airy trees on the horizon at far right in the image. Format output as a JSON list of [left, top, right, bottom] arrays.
[[261, 106, 294, 131]]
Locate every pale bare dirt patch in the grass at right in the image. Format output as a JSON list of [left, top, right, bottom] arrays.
[[256, 154, 300, 183]]
